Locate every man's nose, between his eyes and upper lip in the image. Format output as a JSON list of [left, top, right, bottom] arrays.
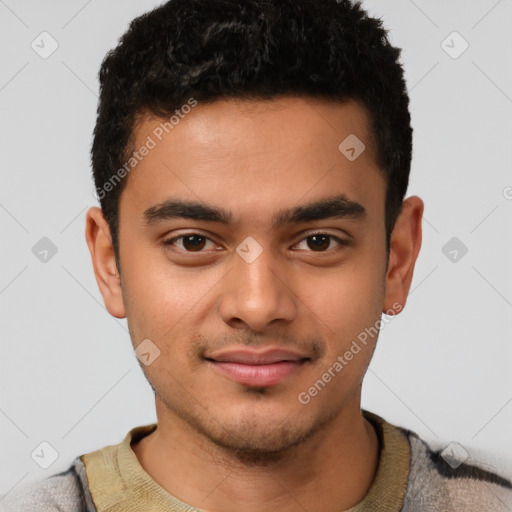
[[219, 243, 297, 332]]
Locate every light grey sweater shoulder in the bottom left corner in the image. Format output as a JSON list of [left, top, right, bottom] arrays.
[[0, 457, 96, 512]]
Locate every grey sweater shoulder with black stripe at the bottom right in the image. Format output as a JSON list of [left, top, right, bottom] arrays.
[[401, 429, 512, 512]]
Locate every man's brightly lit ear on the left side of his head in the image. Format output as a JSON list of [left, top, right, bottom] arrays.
[[85, 206, 126, 318]]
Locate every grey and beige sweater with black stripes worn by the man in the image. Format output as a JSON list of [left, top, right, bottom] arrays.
[[0, 412, 512, 512]]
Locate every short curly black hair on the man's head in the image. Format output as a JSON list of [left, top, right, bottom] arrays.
[[91, 0, 412, 269]]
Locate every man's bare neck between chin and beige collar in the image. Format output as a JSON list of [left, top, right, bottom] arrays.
[[132, 397, 379, 512]]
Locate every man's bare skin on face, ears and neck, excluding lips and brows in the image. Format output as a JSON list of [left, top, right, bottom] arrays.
[[86, 97, 424, 512]]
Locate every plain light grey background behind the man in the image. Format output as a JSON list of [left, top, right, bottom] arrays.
[[0, 0, 512, 493]]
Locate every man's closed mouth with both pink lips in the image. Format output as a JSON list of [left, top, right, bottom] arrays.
[[205, 349, 311, 387]]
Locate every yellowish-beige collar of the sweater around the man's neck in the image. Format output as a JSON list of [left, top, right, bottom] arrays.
[[81, 411, 410, 512]]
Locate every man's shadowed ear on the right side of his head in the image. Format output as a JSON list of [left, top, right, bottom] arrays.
[[383, 196, 425, 314]]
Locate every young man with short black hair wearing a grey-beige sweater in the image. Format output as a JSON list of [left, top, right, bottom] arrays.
[[4, 0, 512, 512]]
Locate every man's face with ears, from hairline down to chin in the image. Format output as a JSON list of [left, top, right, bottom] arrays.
[[87, 98, 421, 460]]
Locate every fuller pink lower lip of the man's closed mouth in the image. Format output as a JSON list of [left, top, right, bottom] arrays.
[[212, 361, 305, 387]]
